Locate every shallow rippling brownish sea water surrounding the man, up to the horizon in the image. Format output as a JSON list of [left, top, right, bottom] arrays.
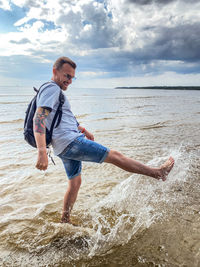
[[0, 88, 200, 267]]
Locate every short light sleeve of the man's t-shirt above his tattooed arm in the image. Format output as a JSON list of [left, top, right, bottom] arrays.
[[37, 84, 60, 111]]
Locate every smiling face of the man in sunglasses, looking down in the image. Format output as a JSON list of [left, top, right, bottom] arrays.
[[53, 63, 75, 91]]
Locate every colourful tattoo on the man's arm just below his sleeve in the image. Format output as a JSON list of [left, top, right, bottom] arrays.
[[33, 108, 49, 134]]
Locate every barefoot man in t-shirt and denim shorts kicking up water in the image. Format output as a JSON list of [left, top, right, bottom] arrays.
[[33, 57, 174, 223]]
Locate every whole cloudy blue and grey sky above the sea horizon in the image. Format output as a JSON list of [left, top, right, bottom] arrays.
[[0, 0, 200, 87]]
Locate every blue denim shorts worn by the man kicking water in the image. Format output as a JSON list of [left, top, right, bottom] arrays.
[[58, 135, 110, 179]]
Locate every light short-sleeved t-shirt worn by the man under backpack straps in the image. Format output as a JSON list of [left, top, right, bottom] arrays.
[[37, 81, 82, 155]]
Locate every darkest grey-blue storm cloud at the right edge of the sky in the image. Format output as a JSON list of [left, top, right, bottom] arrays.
[[140, 23, 200, 62]]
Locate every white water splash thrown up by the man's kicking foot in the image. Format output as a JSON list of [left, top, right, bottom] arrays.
[[85, 147, 190, 257]]
